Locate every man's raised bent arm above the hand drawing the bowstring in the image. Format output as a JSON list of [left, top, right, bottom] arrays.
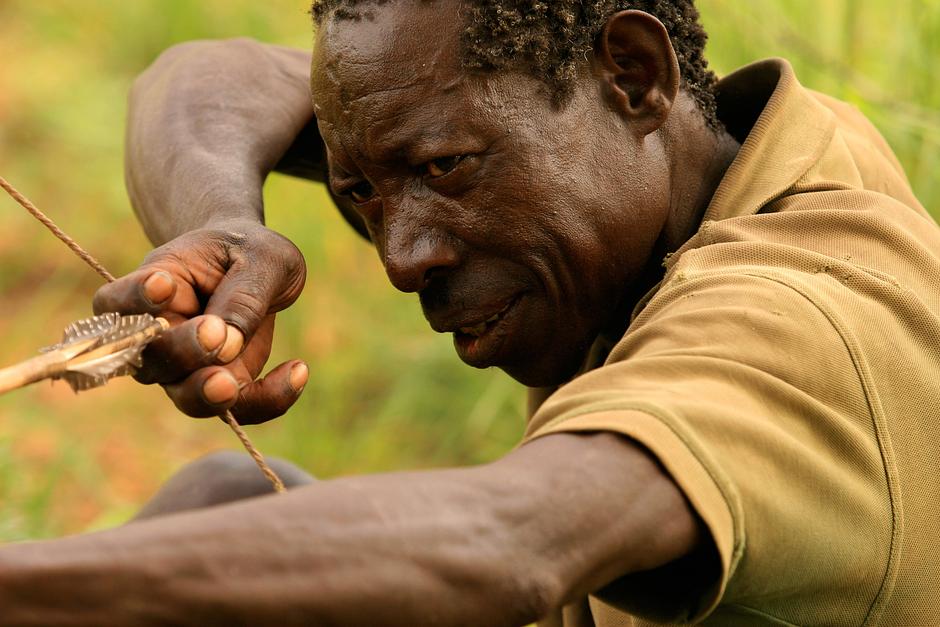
[[125, 39, 322, 244]]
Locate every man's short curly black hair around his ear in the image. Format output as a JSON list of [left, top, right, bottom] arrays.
[[310, 0, 720, 129]]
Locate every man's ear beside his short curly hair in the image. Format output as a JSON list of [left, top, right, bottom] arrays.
[[594, 10, 679, 136]]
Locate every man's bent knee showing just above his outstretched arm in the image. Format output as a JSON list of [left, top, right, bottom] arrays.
[[131, 451, 315, 522]]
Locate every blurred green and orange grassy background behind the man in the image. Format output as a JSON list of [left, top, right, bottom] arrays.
[[0, 0, 940, 542]]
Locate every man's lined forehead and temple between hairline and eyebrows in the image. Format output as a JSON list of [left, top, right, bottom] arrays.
[[311, 0, 553, 170]]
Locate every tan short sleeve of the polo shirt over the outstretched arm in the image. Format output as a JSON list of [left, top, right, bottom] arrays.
[[526, 272, 891, 624]]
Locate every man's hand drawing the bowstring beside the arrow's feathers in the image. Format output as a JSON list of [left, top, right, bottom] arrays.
[[94, 222, 307, 424]]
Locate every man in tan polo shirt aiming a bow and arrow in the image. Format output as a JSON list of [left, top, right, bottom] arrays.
[[0, 0, 940, 626]]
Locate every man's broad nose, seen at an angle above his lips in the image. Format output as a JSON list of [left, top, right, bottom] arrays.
[[383, 211, 460, 292]]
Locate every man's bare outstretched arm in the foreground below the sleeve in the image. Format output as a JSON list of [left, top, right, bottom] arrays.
[[0, 434, 701, 627]]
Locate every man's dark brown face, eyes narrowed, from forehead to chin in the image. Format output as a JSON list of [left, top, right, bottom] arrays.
[[312, 0, 668, 385]]
